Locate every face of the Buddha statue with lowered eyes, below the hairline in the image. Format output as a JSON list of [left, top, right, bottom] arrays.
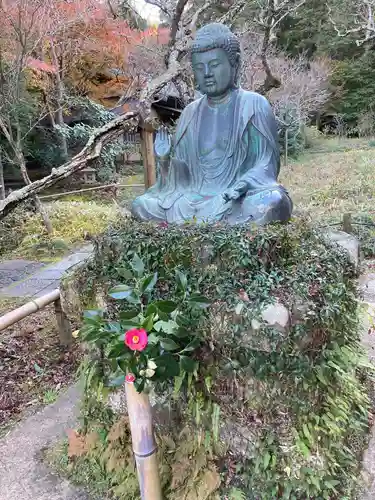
[[192, 49, 236, 97]]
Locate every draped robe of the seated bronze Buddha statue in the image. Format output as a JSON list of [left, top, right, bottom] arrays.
[[132, 89, 292, 223]]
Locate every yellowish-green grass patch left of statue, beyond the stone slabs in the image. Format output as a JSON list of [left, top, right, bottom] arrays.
[[0, 175, 144, 262]]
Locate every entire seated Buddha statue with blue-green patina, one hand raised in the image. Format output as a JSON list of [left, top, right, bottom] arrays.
[[132, 23, 292, 224]]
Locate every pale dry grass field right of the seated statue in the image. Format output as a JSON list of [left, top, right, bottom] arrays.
[[280, 140, 375, 220]]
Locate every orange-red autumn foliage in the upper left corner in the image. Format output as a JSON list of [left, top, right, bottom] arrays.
[[0, 0, 169, 104]]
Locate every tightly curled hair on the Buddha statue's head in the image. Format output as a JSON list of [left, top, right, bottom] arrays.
[[190, 23, 241, 87]]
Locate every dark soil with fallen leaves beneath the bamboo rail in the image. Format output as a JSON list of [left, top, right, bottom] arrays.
[[0, 307, 81, 434]]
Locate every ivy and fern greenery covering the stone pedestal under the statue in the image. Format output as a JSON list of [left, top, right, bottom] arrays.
[[63, 221, 369, 500]]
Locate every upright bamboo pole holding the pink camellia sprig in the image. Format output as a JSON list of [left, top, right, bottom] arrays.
[[125, 374, 162, 500]]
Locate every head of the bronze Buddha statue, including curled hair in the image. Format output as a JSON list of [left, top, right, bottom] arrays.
[[191, 23, 241, 97]]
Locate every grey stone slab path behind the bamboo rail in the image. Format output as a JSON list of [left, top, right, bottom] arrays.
[[0, 245, 92, 298]]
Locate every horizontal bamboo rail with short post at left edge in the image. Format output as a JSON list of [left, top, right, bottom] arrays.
[[0, 288, 73, 346]]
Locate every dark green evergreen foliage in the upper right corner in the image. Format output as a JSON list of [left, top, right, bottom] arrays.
[[277, 0, 375, 130]]
